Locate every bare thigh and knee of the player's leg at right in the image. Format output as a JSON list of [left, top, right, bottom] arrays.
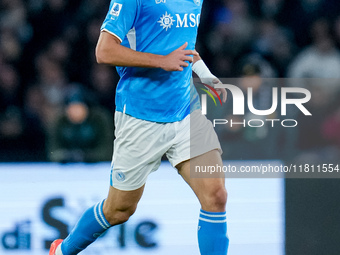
[[176, 150, 227, 211]]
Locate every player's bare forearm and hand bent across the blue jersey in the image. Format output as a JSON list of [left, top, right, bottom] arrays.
[[96, 31, 198, 71]]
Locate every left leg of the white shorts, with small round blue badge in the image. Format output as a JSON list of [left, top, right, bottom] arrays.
[[111, 112, 173, 191]]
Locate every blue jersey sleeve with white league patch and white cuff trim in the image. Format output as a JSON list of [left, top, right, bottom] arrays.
[[100, 0, 138, 42]]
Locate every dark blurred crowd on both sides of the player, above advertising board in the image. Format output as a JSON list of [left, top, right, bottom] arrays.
[[0, 0, 340, 162]]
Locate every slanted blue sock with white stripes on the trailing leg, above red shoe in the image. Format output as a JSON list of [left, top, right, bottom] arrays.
[[61, 200, 111, 255]]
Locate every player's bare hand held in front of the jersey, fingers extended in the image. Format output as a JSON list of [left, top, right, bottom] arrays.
[[161, 42, 198, 71]]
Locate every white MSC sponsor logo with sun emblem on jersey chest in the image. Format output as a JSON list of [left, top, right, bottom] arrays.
[[158, 12, 201, 31]]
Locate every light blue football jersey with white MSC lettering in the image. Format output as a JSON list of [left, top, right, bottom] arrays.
[[101, 0, 203, 122]]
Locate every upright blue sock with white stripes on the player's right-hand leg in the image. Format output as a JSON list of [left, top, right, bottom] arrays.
[[198, 210, 229, 255]]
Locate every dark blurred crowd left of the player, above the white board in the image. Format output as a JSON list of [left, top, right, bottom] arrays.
[[0, 0, 118, 161]]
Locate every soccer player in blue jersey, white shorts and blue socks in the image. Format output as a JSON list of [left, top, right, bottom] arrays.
[[50, 0, 229, 255]]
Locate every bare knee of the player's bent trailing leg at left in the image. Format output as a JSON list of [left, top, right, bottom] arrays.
[[103, 185, 145, 225]]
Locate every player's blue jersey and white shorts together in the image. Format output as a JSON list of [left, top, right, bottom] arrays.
[[101, 0, 220, 190]]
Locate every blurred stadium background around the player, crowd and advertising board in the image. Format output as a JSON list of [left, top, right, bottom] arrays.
[[0, 0, 340, 255]]
